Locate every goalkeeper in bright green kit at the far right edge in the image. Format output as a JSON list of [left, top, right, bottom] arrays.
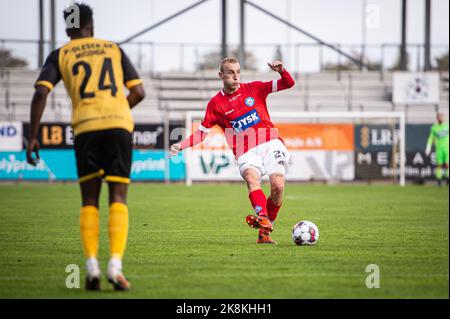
[[425, 113, 448, 186]]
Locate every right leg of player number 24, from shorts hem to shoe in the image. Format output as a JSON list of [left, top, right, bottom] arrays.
[[107, 182, 131, 290]]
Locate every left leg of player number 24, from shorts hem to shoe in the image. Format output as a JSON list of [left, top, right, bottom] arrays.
[[80, 177, 101, 290]]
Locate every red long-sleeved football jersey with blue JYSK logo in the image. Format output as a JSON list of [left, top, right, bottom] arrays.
[[199, 70, 295, 158]]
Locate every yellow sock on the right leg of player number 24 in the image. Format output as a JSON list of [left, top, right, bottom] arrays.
[[109, 202, 128, 259]]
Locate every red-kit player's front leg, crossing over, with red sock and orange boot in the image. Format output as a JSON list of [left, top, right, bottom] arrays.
[[242, 167, 272, 233]]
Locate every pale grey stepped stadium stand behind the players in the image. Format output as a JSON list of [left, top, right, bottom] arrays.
[[0, 69, 449, 124]]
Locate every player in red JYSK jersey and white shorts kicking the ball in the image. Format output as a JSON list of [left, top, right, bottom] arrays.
[[170, 58, 295, 243]]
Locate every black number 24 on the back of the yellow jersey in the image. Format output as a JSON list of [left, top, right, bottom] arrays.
[[72, 58, 117, 99]]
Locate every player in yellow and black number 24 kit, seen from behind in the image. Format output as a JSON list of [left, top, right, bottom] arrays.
[[27, 4, 145, 290]]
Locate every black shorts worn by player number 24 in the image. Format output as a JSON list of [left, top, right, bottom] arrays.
[[74, 129, 132, 184]]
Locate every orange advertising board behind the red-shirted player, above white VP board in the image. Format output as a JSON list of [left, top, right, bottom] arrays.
[[193, 122, 354, 151]]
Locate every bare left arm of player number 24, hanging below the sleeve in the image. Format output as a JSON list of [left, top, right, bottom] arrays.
[[27, 85, 50, 166]]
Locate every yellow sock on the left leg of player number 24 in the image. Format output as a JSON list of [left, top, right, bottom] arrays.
[[80, 206, 99, 258]]
